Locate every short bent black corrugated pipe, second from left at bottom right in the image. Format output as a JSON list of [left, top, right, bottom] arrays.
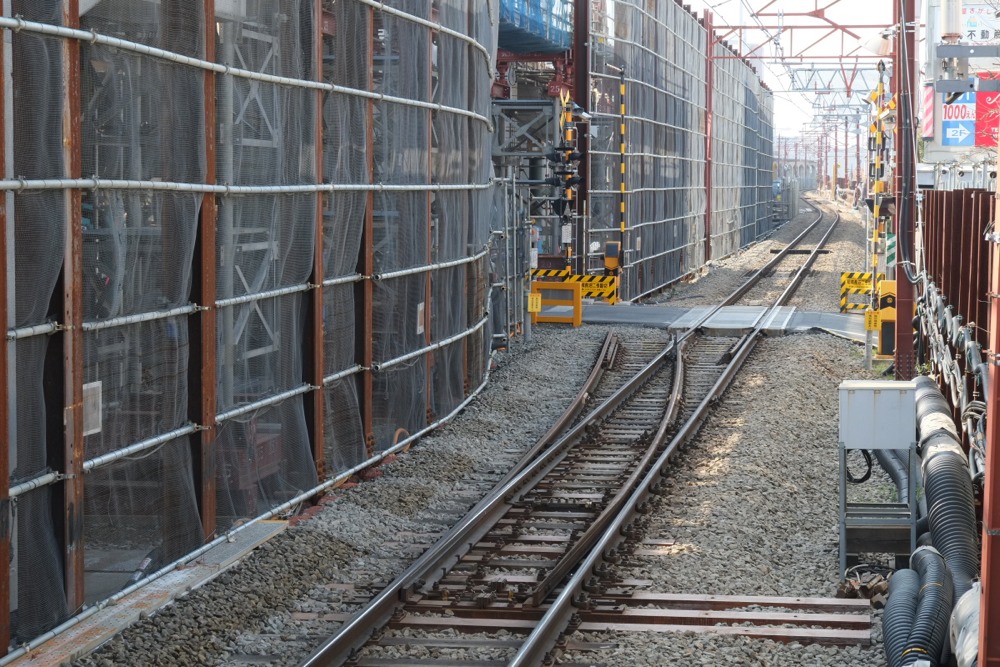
[[899, 547, 954, 667]]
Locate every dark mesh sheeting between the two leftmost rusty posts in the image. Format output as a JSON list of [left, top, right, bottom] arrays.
[[9, 0, 67, 640]]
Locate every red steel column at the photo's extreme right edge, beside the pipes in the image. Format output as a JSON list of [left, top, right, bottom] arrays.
[[979, 157, 1000, 667]]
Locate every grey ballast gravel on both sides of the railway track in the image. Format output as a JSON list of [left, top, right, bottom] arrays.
[[76, 200, 884, 667]]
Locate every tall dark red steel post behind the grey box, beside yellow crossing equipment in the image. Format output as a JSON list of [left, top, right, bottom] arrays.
[[893, 0, 916, 380]]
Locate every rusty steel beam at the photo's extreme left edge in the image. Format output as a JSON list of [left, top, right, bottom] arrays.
[[0, 14, 13, 656]]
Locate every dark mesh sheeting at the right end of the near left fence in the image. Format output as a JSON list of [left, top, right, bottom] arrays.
[[372, 0, 492, 451]]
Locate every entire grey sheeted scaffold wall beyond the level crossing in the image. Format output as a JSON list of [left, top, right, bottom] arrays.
[[587, 0, 773, 299]]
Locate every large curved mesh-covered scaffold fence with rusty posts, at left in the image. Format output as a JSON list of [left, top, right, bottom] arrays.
[[0, 0, 498, 642]]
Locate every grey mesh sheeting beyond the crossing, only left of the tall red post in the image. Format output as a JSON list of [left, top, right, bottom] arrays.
[[590, 0, 707, 299]]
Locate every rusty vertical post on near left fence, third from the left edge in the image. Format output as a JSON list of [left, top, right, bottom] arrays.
[[189, 0, 219, 539]]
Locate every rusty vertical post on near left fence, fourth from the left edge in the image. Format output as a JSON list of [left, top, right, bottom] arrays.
[[305, 0, 326, 479]]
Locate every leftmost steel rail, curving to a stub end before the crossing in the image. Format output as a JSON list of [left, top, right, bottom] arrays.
[[300, 332, 619, 667]]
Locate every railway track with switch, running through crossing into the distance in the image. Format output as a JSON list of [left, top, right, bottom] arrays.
[[302, 200, 848, 667]]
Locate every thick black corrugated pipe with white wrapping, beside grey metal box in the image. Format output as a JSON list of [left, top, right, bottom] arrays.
[[916, 377, 979, 600]]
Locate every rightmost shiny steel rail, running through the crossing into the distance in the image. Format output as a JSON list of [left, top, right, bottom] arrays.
[[508, 205, 840, 667]]
